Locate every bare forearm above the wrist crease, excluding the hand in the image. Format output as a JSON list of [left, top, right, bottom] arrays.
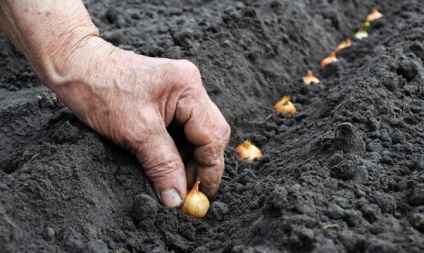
[[0, 0, 99, 90]]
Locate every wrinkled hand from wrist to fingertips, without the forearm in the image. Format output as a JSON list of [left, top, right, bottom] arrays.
[[57, 37, 230, 207]]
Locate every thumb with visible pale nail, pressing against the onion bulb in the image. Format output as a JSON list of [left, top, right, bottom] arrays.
[[136, 127, 187, 208]]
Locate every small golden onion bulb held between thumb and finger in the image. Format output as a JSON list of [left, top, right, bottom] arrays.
[[180, 178, 210, 219]]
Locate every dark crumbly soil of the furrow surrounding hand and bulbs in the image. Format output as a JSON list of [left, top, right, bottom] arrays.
[[0, 0, 424, 253]]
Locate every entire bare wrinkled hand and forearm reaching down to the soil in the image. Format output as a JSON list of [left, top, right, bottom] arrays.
[[0, 0, 230, 207]]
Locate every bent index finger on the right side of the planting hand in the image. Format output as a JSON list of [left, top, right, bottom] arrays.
[[175, 94, 231, 198]]
